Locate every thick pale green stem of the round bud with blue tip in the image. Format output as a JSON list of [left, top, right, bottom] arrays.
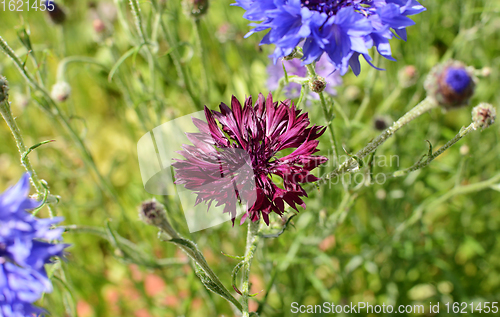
[[318, 97, 438, 184]]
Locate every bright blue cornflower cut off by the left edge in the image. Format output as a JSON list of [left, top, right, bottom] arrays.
[[0, 174, 67, 317]]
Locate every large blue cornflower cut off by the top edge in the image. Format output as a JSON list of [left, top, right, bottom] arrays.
[[235, 0, 425, 75]]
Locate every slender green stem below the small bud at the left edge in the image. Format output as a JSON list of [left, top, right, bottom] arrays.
[[0, 82, 54, 218]]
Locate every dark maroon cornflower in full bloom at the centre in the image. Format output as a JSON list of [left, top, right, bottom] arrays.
[[173, 94, 327, 224]]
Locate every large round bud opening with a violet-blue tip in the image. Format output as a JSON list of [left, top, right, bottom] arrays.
[[424, 60, 477, 109]]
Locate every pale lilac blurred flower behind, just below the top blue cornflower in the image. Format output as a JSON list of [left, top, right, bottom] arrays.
[[267, 56, 342, 99]]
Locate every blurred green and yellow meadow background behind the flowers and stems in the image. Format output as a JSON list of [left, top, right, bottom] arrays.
[[0, 0, 500, 317]]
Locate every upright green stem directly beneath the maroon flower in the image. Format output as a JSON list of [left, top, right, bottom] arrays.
[[241, 221, 259, 317]]
